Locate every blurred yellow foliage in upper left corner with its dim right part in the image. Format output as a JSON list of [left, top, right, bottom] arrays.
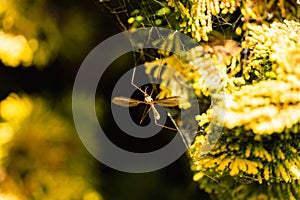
[[0, 0, 95, 68]]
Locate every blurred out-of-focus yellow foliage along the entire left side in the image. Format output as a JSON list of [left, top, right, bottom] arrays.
[[0, 0, 102, 200]]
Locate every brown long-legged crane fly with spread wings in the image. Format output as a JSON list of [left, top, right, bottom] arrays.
[[112, 68, 179, 131]]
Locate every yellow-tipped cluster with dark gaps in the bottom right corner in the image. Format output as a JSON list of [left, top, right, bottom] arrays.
[[190, 120, 300, 200]]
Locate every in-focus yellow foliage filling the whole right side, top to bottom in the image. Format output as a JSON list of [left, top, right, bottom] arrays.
[[102, 0, 300, 199]]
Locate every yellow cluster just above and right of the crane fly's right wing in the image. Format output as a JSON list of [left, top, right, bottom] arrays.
[[145, 46, 212, 108]]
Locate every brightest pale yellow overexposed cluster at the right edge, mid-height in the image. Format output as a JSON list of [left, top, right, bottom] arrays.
[[224, 80, 300, 134]]
